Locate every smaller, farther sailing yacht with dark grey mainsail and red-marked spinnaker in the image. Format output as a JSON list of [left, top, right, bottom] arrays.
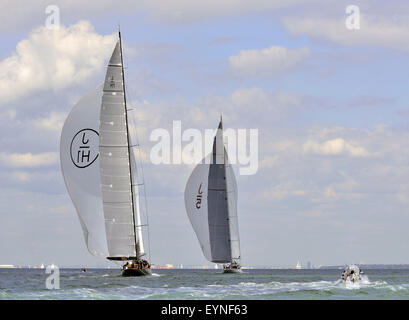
[[185, 119, 241, 273]]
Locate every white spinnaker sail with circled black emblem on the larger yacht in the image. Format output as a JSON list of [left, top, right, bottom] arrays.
[[60, 86, 108, 256]]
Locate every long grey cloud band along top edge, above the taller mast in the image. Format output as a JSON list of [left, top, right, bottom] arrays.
[[0, 0, 304, 31]]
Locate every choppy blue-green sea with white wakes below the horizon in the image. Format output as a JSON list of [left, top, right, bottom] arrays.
[[0, 269, 409, 300]]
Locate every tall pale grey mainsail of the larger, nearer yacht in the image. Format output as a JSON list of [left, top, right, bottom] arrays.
[[99, 40, 140, 257]]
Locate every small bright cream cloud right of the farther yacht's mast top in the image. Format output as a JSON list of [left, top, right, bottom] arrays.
[[303, 138, 369, 157]]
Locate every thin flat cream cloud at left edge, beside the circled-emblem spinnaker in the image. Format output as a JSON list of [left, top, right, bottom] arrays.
[[0, 152, 59, 167]]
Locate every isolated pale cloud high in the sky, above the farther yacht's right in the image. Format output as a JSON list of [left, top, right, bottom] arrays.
[[229, 46, 310, 76]]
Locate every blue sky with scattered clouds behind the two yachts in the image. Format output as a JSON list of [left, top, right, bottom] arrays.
[[0, 0, 409, 266]]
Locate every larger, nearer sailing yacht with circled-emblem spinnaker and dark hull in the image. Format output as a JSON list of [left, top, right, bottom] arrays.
[[60, 33, 151, 276]]
